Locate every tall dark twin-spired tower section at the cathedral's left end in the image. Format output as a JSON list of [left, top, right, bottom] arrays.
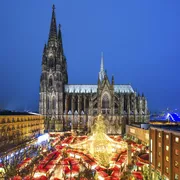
[[39, 5, 68, 131]]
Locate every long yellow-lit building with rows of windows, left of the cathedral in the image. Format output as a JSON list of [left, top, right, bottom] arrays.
[[0, 112, 44, 152]]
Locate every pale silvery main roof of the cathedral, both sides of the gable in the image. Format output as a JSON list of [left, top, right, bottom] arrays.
[[65, 84, 134, 93]]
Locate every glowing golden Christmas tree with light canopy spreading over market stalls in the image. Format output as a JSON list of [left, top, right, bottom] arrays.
[[69, 115, 127, 166]]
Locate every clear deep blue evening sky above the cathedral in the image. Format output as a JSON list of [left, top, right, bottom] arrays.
[[0, 0, 180, 111]]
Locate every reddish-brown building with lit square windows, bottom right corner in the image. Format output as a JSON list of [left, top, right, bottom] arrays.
[[150, 122, 180, 180]]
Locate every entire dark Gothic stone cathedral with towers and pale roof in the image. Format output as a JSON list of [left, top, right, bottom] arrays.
[[39, 5, 149, 134]]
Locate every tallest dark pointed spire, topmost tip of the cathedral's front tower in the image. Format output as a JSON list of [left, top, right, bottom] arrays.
[[49, 4, 57, 41]]
